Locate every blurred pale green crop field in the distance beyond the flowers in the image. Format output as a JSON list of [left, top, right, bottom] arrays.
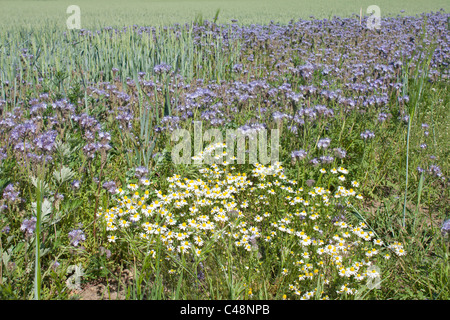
[[0, 0, 450, 30]]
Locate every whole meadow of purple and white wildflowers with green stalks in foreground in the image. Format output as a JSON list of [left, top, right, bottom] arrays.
[[0, 1, 450, 300]]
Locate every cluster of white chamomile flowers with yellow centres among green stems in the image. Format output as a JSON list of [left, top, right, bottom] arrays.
[[100, 144, 406, 299]]
